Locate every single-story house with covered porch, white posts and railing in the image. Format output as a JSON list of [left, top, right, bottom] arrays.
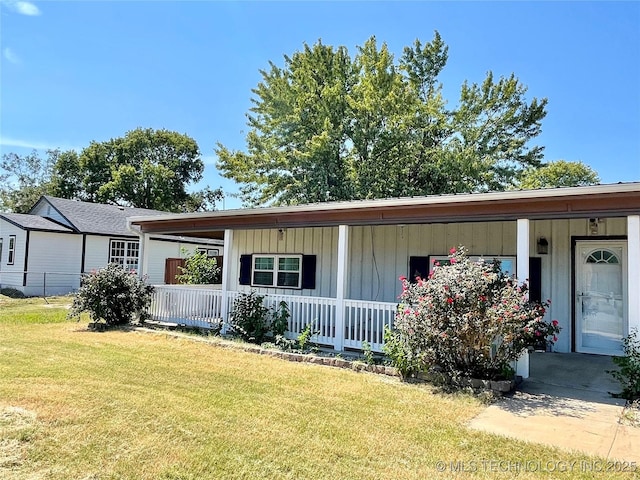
[[129, 182, 640, 368]]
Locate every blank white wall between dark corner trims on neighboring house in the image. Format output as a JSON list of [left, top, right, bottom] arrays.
[[24, 231, 82, 295]]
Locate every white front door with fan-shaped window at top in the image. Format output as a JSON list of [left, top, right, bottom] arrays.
[[575, 240, 628, 355]]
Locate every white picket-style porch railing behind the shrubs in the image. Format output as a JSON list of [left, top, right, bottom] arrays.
[[149, 285, 397, 352]]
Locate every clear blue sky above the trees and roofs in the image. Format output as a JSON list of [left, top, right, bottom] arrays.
[[0, 0, 640, 208]]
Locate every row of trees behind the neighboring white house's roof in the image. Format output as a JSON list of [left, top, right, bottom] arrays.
[[0, 128, 222, 212]]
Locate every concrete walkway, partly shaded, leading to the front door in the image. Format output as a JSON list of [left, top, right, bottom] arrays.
[[470, 353, 640, 464]]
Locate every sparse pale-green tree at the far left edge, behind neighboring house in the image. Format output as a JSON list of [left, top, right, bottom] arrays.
[[0, 150, 66, 213]]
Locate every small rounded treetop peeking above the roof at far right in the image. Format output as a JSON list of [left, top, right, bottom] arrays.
[[516, 160, 600, 190]]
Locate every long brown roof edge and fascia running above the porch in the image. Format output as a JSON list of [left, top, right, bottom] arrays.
[[130, 183, 640, 239]]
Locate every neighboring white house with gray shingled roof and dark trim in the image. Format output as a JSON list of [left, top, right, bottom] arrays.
[[0, 196, 222, 295]]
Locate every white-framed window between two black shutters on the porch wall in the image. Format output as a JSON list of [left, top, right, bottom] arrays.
[[251, 255, 302, 288]]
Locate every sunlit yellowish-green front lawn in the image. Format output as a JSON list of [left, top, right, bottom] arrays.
[[0, 299, 632, 480]]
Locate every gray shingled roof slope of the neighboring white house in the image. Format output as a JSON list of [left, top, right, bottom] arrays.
[[38, 195, 168, 236]]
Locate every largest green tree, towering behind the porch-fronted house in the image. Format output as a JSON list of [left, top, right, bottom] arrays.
[[216, 32, 547, 205]]
